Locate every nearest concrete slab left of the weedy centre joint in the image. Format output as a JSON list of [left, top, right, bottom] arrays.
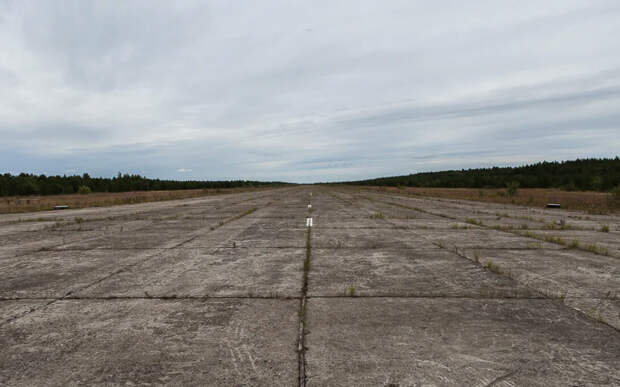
[[0, 300, 299, 386]]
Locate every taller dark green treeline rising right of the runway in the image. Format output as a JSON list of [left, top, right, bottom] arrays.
[[341, 156, 620, 191]]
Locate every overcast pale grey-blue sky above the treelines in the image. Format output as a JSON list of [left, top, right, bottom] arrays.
[[0, 0, 620, 182]]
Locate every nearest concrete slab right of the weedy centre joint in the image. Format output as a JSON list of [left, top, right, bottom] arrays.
[[306, 298, 620, 386]]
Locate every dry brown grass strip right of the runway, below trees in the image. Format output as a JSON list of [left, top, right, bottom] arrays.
[[360, 187, 619, 214]]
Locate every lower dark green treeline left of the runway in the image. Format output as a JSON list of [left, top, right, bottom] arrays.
[[0, 173, 287, 196]]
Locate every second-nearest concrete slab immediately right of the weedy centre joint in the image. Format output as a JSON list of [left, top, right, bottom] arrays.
[[308, 249, 538, 298]]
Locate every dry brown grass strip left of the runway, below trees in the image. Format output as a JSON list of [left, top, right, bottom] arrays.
[[0, 187, 270, 213]]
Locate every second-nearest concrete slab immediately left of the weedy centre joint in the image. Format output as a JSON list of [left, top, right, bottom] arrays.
[[75, 248, 305, 297]]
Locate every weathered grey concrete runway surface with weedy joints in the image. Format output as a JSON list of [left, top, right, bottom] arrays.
[[0, 186, 620, 386]]
